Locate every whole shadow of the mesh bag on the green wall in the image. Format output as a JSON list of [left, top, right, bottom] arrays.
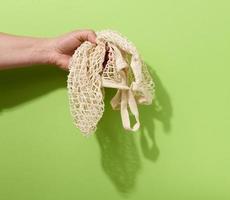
[[96, 67, 172, 195]]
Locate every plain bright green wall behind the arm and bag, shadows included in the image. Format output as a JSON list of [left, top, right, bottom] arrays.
[[0, 0, 230, 200]]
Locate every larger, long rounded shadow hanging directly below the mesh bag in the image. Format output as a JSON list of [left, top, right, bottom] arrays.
[[96, 88, 141, 195]]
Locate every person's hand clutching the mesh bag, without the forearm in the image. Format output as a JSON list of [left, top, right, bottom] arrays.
[[48, 30, 96, 70]]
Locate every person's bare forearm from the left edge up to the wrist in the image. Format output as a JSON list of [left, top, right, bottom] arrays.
[[0, 33, 51, 69]]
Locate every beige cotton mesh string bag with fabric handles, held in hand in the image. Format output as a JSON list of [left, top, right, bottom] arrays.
[[67, 30, 155, 135]]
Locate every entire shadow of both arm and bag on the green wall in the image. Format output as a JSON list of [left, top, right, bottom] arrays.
[[0, 66, 172, 197]]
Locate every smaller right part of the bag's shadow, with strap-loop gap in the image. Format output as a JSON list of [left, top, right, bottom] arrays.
[[139, 66, 173, 162]]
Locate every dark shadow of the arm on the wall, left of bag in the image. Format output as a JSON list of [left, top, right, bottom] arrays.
[[0, 66, 67, 112]]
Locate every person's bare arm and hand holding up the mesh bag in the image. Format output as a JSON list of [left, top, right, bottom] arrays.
[[0, 29, 96, 70]]
